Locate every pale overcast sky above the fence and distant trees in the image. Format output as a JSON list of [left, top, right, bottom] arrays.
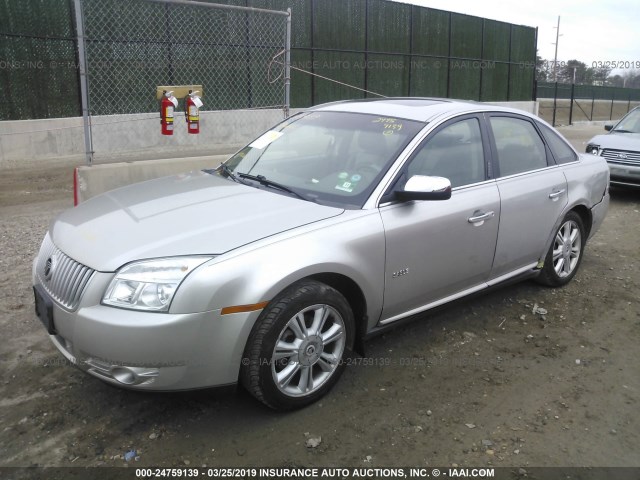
[[396, 0, 640, 73]]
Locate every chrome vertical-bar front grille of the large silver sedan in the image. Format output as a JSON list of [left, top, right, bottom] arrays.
[[36, 234, 94, 310]]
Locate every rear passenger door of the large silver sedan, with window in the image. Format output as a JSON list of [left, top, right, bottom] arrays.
[[489, 114, 568, 280]]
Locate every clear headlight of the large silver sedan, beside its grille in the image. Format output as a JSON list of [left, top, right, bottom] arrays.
[[102, 257, 211, 312]]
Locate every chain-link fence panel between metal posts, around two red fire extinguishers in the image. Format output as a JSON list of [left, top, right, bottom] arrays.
[[75, 0, 290, 162]]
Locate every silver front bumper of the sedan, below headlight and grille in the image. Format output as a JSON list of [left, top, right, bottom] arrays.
[[33, 263, 260, 390]]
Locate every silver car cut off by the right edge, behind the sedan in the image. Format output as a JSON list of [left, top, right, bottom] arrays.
[[587, 107, 640, 187]]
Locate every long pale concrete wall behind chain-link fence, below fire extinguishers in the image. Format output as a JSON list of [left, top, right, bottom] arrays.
[[0, 109, 284, 169]]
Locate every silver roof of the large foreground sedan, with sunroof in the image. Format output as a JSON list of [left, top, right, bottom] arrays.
[[311, 97, 531, 122]]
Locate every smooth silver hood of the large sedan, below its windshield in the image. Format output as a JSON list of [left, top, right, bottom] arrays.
[[51, 172, 344, 272]]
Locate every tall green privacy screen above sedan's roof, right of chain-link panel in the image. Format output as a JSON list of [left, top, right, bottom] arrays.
[[288, 0, 536, 107]]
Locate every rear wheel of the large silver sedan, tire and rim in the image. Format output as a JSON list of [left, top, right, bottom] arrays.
[[537, 211, 586, 287]]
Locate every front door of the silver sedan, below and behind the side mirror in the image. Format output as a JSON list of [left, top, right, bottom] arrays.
[[380, 115, 500, 323]]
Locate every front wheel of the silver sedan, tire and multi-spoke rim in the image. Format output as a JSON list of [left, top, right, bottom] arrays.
[[240, 281, 355, 410]]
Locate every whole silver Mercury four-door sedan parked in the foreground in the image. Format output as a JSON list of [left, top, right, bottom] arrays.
[[33, 98, 609, 409]]
